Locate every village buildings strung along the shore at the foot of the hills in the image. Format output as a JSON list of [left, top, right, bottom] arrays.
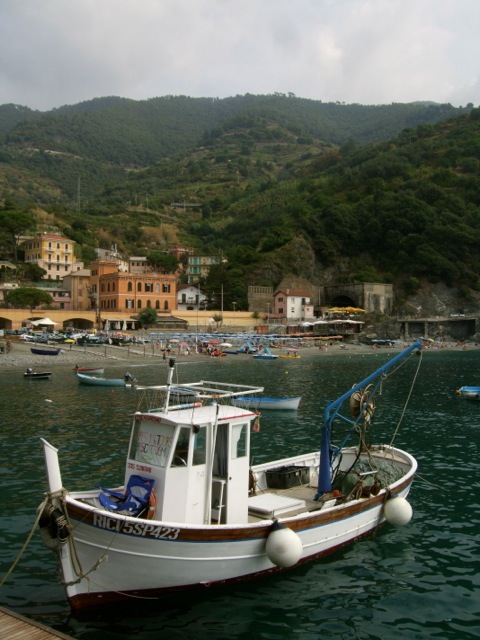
[[0, 232, 477, 348]]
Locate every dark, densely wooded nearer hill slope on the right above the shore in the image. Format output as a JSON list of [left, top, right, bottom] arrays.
[[202, 109, 480, 304]]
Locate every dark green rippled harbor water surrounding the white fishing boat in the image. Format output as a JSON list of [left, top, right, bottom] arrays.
[[0, 349, 480, 640]]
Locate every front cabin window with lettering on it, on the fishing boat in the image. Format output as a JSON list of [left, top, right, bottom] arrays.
[[130, 420, 174, 467]]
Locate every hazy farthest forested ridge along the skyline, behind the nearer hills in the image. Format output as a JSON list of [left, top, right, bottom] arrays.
[[0, 94, 470, 167]]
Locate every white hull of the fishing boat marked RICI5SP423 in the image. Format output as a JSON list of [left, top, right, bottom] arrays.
[[49, 449, 416, 610]]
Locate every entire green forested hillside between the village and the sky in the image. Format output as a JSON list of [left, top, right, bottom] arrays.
[[0, 96, 480, 309]]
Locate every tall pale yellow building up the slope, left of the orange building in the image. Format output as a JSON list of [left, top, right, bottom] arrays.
[[23, 233, 83, 280]]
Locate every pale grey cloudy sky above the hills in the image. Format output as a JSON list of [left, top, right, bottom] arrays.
[[0, 0, 480, 110]]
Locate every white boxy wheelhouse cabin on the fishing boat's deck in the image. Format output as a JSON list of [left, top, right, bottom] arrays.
[[125, 383, 263, 524]]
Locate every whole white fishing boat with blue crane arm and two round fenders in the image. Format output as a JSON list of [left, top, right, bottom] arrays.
[[38, 343, 421, 610]]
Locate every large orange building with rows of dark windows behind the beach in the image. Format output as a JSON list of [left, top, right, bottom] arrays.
[[90, 260, 177, 315]]
